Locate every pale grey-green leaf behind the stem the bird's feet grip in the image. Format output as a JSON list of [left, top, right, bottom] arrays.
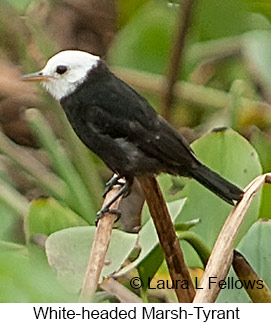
[[46, 226, 137, 292]]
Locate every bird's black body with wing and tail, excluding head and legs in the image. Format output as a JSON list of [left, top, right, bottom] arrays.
[[60, 61, 243, 204]]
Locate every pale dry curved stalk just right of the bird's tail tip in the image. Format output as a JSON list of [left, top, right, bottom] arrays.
[[194, 173, 271, 303]]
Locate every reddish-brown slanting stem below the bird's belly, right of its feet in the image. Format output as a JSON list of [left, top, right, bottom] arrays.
[[138, 176, 195, 303]]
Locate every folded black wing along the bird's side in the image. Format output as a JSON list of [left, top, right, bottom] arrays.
[[82, 69, 197, 171]]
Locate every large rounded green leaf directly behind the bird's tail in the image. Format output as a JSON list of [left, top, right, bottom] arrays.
[[176, 130, 262, 266]]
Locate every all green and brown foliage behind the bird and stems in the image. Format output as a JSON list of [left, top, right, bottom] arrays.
[[0, 0, 271, 302]]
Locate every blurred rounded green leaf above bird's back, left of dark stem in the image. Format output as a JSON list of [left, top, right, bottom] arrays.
[[108, 1, 176, 74]]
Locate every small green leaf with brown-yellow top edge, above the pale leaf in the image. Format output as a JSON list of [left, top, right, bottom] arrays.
[[25, 198, 88, 242]]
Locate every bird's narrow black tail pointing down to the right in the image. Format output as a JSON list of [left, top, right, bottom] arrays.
[[191, 165, 244, 205]]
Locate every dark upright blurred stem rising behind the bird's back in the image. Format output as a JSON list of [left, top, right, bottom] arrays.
[[161, 0, 195, 121]]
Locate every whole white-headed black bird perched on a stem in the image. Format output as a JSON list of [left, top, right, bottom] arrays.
[[22, 50, 243, 218]]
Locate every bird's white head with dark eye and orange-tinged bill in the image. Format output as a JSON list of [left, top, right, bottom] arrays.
[[22, 50, 100, 100]]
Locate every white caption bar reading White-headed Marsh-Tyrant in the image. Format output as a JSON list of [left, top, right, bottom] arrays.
[[0, 303, 271, 323]]
